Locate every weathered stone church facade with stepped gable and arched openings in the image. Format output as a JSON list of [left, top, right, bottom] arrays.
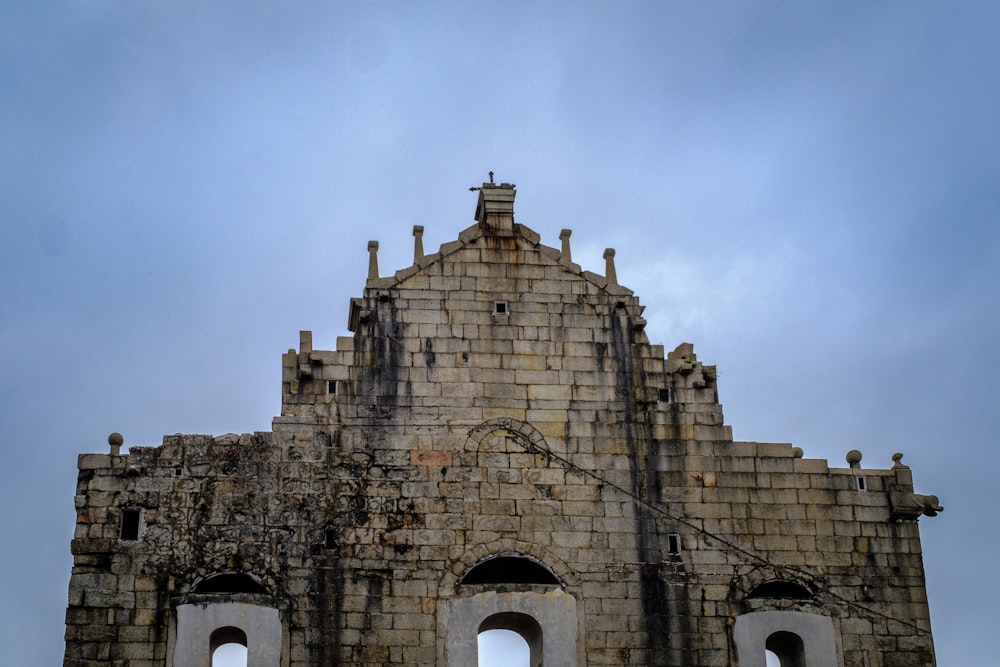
[[64, 183, 941, 667]]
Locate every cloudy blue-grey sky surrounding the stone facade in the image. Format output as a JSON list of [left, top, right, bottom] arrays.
[[0, 0, 1000, 665]]
